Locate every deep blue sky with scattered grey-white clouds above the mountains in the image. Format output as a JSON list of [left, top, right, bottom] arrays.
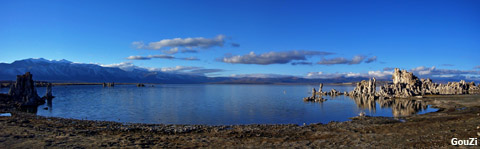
[[0, 0, 480, 80]]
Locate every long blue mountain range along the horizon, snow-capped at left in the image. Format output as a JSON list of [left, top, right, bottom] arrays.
[[0, 58, 368, 84]]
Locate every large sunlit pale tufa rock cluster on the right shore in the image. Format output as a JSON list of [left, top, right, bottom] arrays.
[[348, 68, 480, 98]]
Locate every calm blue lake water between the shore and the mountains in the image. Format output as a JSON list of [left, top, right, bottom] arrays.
[[0, 84, 437, 125]]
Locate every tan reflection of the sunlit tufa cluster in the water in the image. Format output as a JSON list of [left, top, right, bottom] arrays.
[[352, 97, 428, 117]]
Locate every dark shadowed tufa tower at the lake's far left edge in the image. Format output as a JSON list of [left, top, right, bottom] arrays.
[[8, 72, 45, 106]]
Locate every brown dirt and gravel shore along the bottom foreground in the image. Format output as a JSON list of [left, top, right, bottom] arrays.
[[0, 95, 480, 148]]
